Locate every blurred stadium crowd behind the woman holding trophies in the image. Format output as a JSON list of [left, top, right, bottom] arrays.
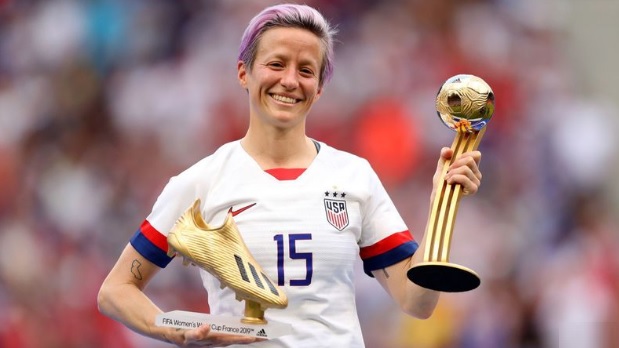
[[0, 0, 619, 348]]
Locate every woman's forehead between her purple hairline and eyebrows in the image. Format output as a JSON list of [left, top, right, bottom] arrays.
[[256, 28, 323, 64]]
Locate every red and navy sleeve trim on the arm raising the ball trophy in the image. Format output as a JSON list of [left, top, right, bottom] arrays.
[[359, 231, 419, 277]]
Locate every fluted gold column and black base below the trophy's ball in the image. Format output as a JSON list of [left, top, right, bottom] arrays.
[[408, 127, 486, 292]]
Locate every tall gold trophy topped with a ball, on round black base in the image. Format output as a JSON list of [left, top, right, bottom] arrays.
[[407, 74, 494, 292]]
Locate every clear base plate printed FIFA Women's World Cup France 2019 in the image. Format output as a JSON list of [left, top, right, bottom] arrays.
[[155, 311, 292, 339]]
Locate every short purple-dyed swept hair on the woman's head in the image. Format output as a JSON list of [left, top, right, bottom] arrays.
[[238, 4, 337, 86]]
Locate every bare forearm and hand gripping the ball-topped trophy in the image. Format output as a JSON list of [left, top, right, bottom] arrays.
[[372, 148, 481, 319]]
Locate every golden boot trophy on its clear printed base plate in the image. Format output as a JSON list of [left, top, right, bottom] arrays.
[[158, 199, 289, 338]]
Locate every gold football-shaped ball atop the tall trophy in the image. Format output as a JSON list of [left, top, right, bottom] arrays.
[[436, 74, 494, 133]]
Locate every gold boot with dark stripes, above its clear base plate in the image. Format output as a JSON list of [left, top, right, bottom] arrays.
[[168, 199, 288, 323]]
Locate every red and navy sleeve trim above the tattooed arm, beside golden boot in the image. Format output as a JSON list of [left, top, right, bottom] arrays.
[[130, 220, 173, 268]]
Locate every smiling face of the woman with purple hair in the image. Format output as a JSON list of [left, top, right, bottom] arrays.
[[238, 27, 323, 130]]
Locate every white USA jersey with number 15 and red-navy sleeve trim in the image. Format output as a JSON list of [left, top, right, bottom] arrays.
[[132, 141, 417, 347]]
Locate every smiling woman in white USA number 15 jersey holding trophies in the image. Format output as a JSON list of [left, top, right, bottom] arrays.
[[98, 4, 481, 347]]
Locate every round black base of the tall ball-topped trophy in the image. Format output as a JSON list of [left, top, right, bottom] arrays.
[[406, 261, 481, 292]]
